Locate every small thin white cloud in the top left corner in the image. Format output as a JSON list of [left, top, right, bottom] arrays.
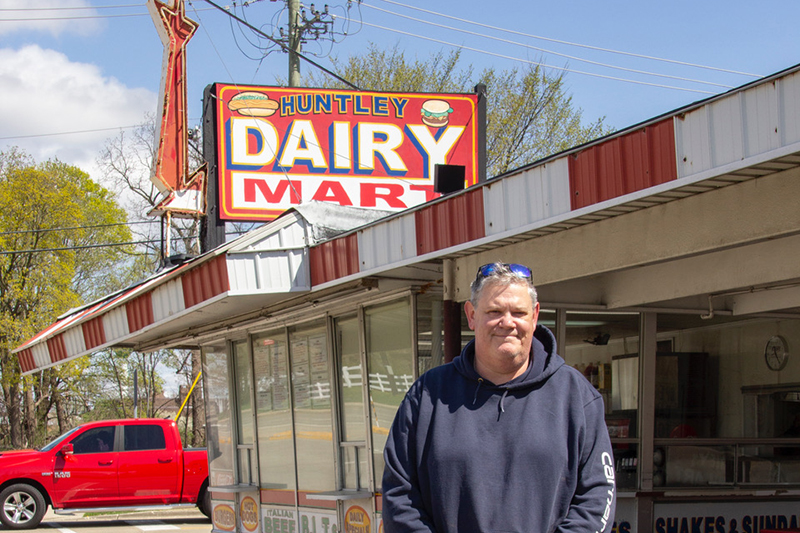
[[0, 0, 100, 37]]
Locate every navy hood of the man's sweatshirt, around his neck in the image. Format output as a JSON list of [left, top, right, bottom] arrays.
[[453, 325, 565, 391]]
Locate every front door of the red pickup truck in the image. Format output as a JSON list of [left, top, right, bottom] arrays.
[[53, 426, 119, 508]]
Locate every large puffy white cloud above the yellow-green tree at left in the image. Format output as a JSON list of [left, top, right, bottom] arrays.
[[0, 45, 157, 180]]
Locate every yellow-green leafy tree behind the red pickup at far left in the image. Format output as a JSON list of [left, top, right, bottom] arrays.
[[0, 149, 130, 447]]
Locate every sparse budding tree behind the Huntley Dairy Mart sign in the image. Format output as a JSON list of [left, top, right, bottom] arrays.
[[296, 44, 610, 177]]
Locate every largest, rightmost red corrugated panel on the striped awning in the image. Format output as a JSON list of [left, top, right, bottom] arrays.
[[567, 117, 678, 210]]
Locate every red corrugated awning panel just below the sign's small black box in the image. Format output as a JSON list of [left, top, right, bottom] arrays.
[[414, 187, 486, 255]]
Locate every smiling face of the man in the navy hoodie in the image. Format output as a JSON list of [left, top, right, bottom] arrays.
[[464, 283, 539, 373]]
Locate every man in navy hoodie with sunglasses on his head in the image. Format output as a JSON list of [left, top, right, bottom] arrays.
[[382, 263, 616, 533]]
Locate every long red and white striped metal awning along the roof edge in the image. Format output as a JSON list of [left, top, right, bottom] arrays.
[[15, 65, 800, 373]]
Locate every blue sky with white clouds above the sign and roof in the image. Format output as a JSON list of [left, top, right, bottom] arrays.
[[0, 0, 800, 180]]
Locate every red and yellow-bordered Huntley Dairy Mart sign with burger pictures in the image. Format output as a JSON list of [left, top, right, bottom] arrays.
[[209, 84, 479, 221]]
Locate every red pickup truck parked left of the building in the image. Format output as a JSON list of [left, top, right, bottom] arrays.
[[0, 418, 210, 529]]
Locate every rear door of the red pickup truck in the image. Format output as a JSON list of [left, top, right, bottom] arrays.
[[118, 424, 182, 505]]
